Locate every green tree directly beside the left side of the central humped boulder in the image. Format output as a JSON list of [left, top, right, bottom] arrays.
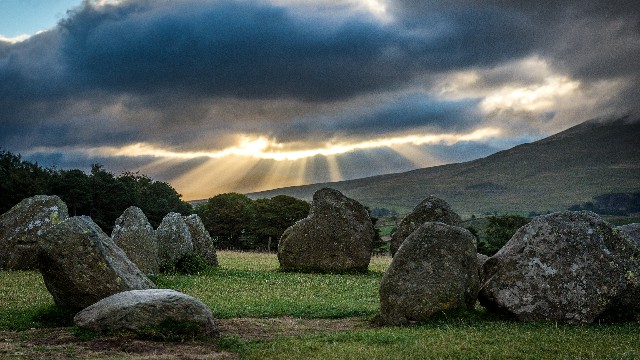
[[253, 195, 311, 251]]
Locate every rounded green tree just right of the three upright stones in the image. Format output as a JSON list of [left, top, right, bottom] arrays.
[[196, 193, 255, 249]]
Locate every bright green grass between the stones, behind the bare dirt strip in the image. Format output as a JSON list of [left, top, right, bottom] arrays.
[[154, 252, 390, 318]]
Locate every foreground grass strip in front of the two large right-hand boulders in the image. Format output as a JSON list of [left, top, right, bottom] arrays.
[[241, 321, 640, 359]]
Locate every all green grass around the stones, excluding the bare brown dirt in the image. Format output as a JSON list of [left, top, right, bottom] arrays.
[[0, 251, 640, 359]]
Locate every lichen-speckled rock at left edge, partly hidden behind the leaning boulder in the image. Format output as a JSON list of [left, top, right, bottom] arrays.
[[0, 195, 69, 270]]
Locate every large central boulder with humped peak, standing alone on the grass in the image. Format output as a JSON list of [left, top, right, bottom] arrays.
[[278, 188, 374, 273]]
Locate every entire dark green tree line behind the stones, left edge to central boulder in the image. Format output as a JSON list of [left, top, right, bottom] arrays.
[[0, 150, 310, 251]]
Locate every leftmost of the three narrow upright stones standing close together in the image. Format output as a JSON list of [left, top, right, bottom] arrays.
[[111, 206, 160, 274]]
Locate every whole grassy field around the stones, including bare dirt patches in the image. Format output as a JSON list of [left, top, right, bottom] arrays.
[[0, 252, 640, 359]]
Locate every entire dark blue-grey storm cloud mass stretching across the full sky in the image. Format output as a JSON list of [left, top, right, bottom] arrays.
[[0, 0, 640, 169]]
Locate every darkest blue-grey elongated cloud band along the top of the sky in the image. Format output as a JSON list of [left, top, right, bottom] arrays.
[[56, 2, 530, 101]]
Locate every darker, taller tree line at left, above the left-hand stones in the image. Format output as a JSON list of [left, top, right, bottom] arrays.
[[0, 151, 193, 234]]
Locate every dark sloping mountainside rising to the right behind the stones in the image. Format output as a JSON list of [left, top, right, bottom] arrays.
[[247, 117, 640, 215]]
